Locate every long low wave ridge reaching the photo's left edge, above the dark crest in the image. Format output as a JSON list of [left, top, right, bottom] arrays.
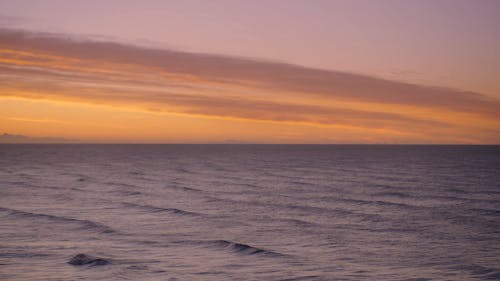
[[0, 207, 117, 234]]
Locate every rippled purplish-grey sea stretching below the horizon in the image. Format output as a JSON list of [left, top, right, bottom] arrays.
[[0, 145, 500, 280]]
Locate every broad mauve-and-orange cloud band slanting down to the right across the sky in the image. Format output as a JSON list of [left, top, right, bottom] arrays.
[[0, 29, 500, 142]]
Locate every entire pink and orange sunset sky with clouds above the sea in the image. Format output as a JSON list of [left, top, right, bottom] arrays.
[[0, 0, 500, 144]]
